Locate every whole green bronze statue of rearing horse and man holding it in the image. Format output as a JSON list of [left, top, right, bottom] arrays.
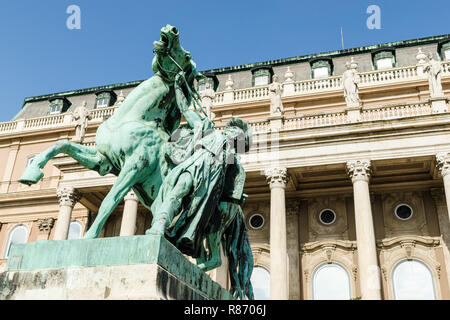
[[19, 25, 253, 299]]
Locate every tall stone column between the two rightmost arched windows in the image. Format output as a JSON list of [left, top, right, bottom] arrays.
[[347, 160, 381, 300]]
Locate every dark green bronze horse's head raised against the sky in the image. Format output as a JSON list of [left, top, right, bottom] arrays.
[[152, 24, 202, 88]]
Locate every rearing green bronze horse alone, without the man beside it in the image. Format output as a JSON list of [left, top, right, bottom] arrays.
[[19, 25, 202, 239]]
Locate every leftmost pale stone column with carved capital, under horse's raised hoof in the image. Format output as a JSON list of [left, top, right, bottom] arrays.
[[53, 187, 81, 240]]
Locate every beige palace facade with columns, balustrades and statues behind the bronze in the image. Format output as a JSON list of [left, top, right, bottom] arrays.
[[0, 35, 450, 300]]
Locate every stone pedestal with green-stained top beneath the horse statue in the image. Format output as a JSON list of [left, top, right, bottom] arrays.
[[0, 235, 232, 300]]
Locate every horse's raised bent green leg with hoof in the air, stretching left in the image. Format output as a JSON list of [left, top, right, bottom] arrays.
[[19, 140, 112, 186]]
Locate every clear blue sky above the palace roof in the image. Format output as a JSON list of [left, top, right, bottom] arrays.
[[0, 0, 450, 121]]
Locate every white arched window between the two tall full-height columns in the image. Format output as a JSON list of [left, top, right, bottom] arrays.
[[313, 263, 350, 300]]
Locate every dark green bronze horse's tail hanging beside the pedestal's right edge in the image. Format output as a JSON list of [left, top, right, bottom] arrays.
[[222, 206, 254, 300]]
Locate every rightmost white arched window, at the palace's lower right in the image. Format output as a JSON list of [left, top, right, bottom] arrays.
[[392, 260, 436, 300]]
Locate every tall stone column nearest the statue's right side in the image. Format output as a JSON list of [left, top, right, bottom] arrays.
[[264, 168, 289, 300]]
